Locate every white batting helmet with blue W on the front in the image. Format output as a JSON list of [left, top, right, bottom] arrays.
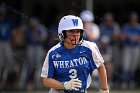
[[58, 15, 84, 41]]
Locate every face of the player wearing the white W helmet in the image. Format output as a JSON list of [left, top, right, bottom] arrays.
[[65, 29, 80, 45]]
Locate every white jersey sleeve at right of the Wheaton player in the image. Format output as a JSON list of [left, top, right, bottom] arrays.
[[91, 43, 104, 68]]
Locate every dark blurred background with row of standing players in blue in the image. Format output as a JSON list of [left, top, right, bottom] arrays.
[[0, 0, 140, 93]]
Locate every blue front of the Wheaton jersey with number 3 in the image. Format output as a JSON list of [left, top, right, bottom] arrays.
[[48, 43, 97, 93]]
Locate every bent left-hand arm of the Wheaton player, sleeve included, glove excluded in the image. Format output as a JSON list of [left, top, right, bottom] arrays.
[[41, 51, 64, 89]]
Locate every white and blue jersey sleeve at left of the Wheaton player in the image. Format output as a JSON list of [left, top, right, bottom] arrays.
[[41, 53, 54, 78]]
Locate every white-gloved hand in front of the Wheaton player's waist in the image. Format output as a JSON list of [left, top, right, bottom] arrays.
[[64, 78, 82, 90]]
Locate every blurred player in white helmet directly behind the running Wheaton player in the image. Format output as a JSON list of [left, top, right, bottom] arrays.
[[80, 10, 100, 42]]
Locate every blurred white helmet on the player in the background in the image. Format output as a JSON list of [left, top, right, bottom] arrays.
[[80, 10, 94, 22]]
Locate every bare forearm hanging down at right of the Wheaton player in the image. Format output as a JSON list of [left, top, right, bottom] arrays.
[[97, 64, 109, 93]]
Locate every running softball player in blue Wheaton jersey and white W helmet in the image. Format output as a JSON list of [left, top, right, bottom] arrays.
[[41, 15, 109, 93]]
